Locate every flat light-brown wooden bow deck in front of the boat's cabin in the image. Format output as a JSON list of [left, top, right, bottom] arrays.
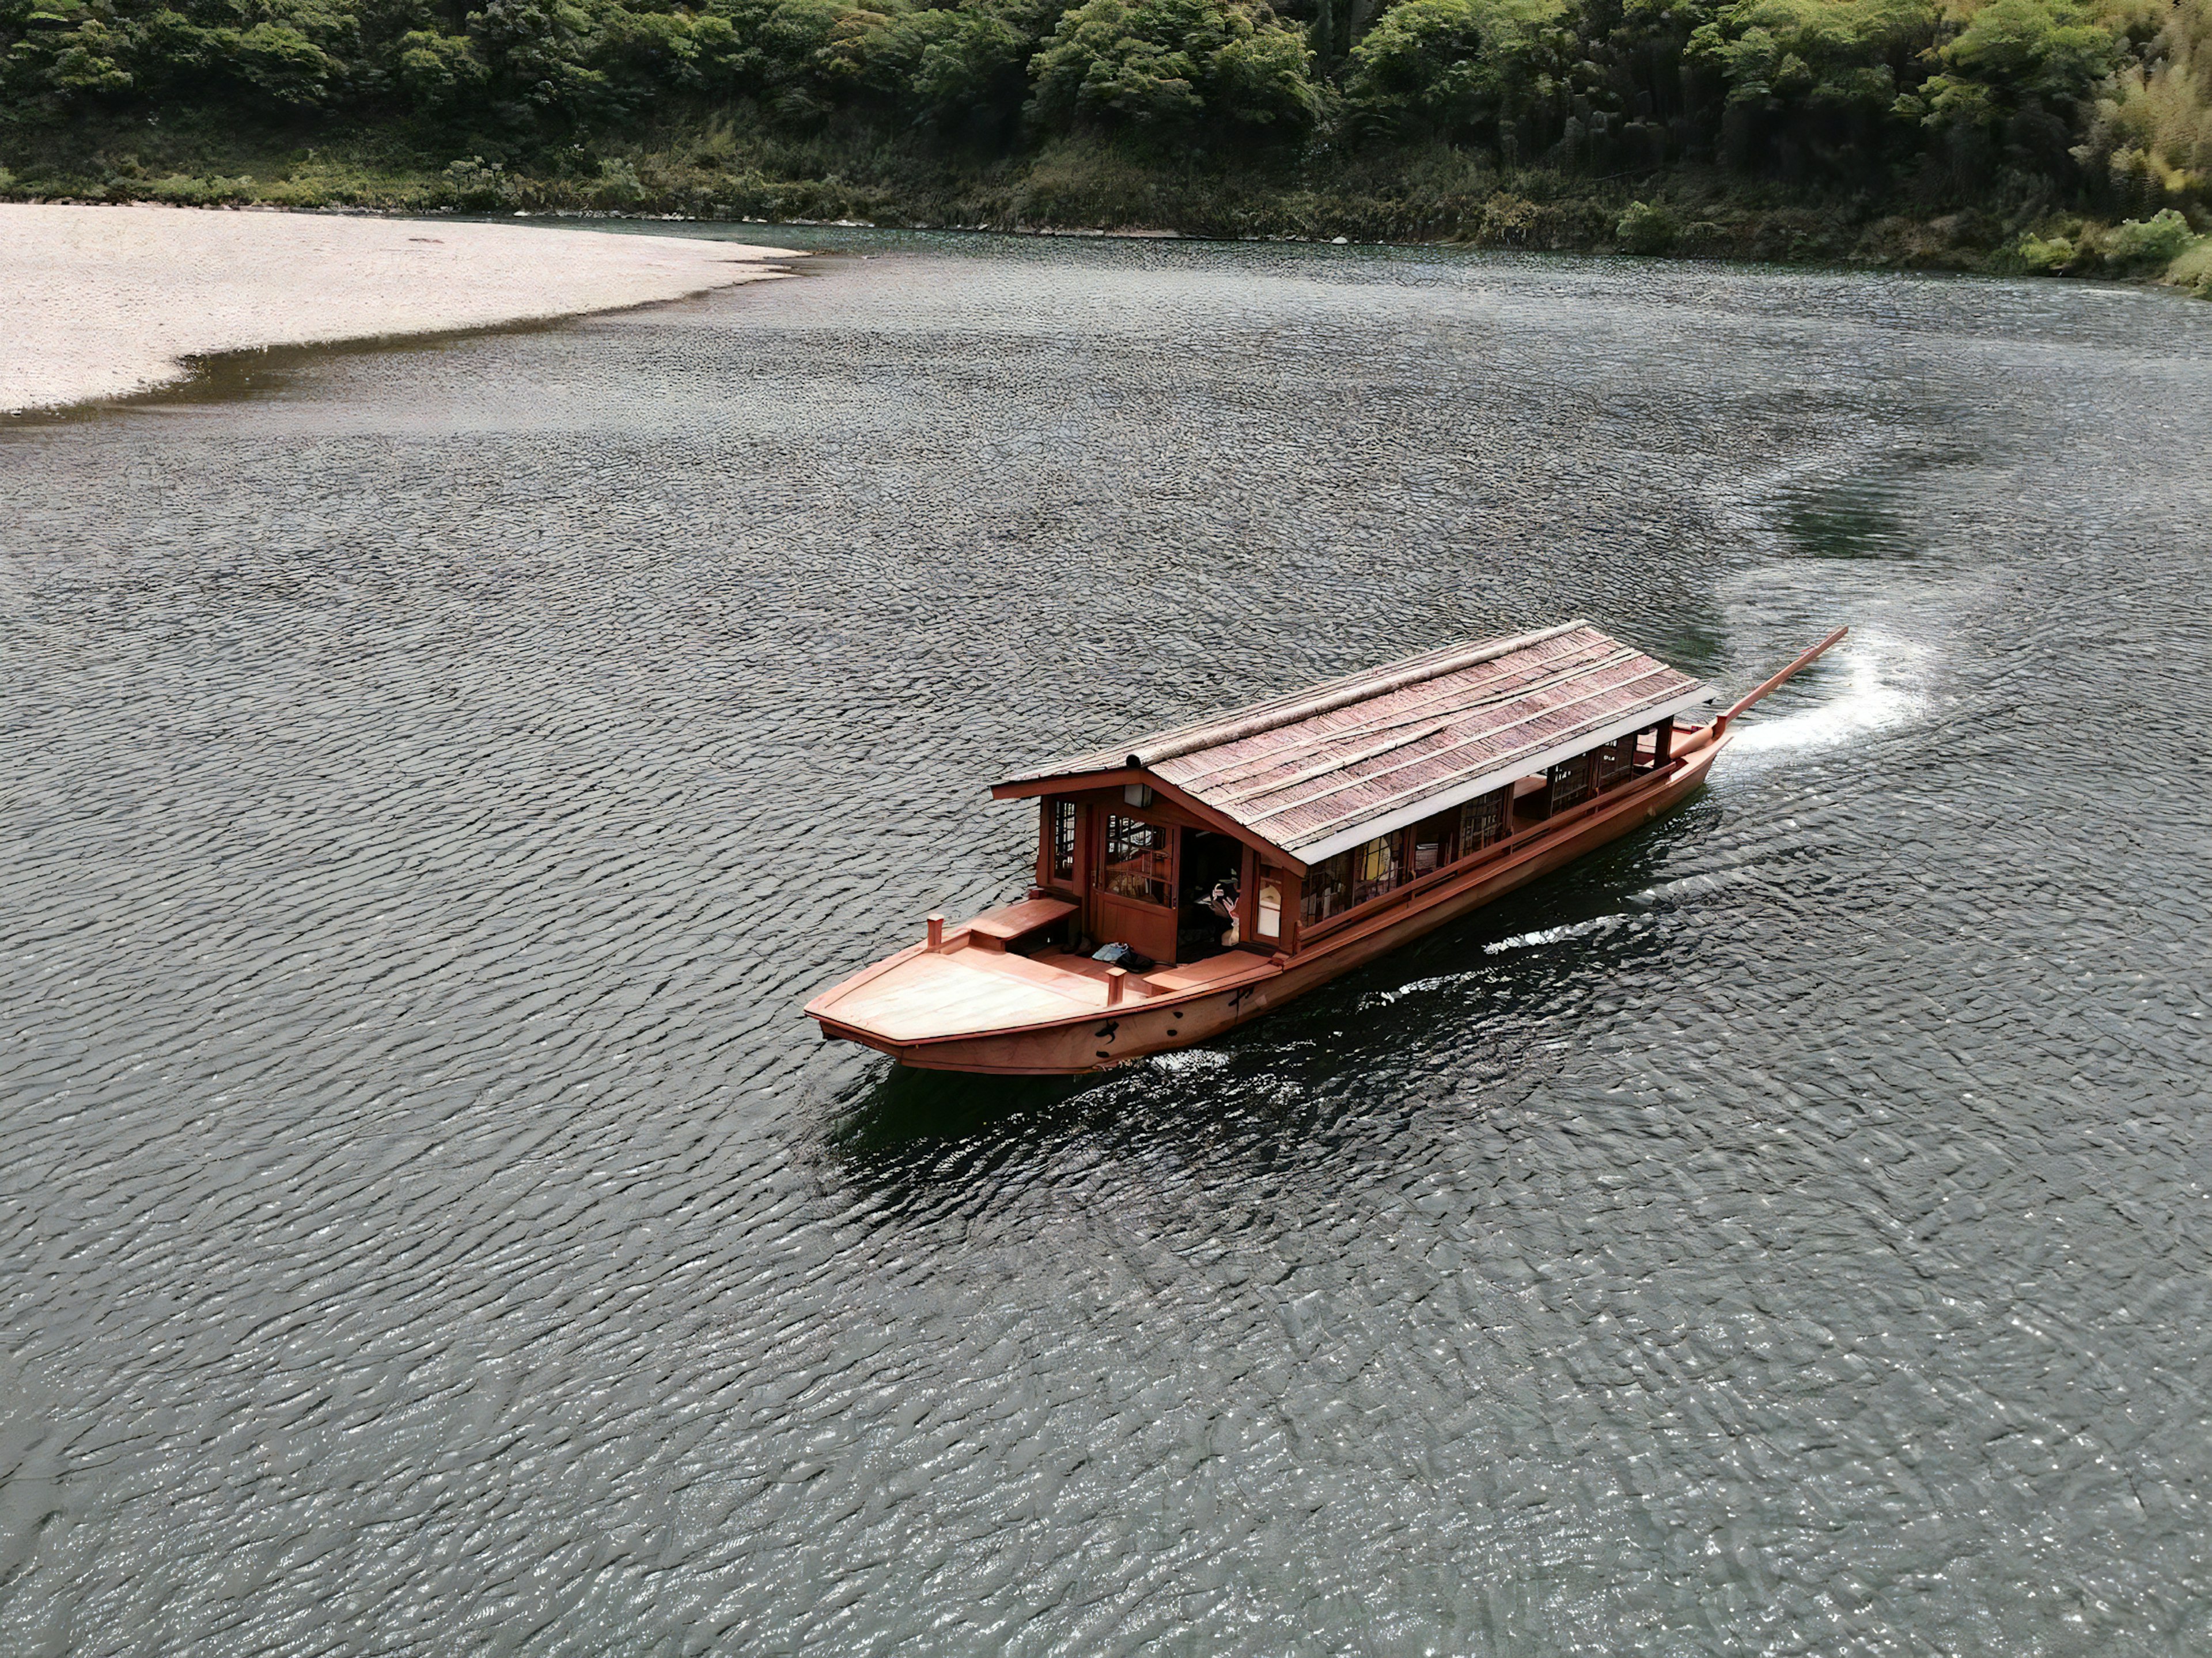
[[812, 938, 1279, 1041]]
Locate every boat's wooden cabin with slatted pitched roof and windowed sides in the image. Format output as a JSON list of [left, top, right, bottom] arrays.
[[995, 621, 1710, 966]]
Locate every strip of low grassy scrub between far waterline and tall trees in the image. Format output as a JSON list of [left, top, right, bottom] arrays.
[[0, 145, 2212, 298]]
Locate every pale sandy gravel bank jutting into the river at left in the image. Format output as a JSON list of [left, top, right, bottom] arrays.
[[0, 203, 796, 411]]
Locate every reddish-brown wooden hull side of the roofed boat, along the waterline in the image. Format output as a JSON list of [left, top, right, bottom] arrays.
[[809, 732, 1728, 1076]]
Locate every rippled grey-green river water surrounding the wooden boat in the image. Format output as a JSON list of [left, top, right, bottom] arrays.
[[0, 227, 2212, 1658]]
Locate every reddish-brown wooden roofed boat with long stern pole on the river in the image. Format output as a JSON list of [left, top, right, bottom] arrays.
[[808, 621, 1845, 1075]]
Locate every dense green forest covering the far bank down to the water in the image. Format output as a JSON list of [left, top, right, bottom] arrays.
[[0, 0, 2212, 283]]
